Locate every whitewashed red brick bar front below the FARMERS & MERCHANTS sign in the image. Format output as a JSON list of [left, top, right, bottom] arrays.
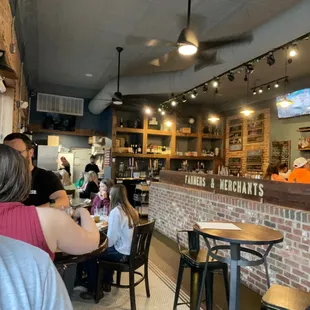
[[149, 183, 310, 295]]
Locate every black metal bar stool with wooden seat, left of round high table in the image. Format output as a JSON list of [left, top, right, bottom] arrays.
[[173, 230, 229, 310]]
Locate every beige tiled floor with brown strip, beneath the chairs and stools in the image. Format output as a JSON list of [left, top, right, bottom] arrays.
[[72, 232, 261, 310]]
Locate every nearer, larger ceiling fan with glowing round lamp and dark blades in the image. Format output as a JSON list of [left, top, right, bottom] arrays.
[[128, 0, 252, 71]]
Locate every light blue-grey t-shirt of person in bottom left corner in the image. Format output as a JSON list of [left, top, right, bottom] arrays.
[[0, 236, 73, 310]]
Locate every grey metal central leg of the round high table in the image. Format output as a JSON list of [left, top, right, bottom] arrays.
[[229, 243, 240, 310]]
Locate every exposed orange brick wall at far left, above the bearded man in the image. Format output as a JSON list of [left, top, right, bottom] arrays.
[[0, 0, 28, 131]]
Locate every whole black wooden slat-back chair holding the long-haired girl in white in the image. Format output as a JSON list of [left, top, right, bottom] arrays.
[[95, 221, 155, 310]]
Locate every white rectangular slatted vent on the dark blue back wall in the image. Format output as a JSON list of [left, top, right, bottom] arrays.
[[37, 93, 84, 116]]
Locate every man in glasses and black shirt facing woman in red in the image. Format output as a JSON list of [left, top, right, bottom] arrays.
[[4, 133, 69, 208]]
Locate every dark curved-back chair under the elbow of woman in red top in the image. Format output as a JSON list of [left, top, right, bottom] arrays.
[[54, 232, 108, 296]]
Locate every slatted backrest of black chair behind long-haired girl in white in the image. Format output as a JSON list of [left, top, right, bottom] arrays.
[[129, 220, 155, 268]]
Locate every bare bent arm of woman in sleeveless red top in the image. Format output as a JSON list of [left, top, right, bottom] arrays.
[[37, 208, 99, 255]]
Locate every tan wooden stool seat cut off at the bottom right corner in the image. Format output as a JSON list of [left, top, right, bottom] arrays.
[[262, 284, 310, 310]]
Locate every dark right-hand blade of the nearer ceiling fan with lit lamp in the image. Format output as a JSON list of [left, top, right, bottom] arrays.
[[199, 33, 253, 51]]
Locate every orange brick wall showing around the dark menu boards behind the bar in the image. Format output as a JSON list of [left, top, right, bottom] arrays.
[[225, 109, 270, 174]]
